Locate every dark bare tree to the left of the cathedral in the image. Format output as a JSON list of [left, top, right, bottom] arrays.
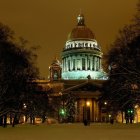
[[0, 23, 38, 126]]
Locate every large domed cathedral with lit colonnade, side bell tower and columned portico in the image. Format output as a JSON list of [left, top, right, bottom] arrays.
[[49, 14, 107, 122]]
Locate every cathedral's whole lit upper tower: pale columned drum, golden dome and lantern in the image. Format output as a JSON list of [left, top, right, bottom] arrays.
[[62, 14, 107, 80]]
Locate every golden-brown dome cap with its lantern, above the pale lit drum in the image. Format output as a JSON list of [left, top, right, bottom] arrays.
[[68, 14, 95, 40]]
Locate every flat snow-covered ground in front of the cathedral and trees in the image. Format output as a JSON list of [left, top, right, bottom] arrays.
[[0, 123, 140, 140]]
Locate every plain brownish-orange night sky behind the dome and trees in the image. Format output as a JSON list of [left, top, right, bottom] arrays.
[[0, 0, 138, 78]]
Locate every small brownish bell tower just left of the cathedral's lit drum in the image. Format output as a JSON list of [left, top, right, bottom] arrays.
[[49, 57, 62, 81]]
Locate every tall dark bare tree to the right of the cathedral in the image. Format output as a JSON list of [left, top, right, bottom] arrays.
[[103, 1, 140, 122]]
